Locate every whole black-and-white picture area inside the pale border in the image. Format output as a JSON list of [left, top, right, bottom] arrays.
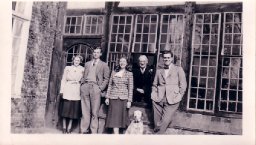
[[1, 1, 255, 144]]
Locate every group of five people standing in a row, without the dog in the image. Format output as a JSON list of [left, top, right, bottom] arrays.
[[59, 47, 187, 134]]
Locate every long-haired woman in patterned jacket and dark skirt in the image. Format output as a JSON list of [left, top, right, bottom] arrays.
[[105, 57, 133, 134]]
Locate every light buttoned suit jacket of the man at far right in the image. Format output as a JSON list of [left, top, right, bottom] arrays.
[[151, 65, 187, 104]]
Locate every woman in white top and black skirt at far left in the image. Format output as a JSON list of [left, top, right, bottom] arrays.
[[59, 55, 84, 134]]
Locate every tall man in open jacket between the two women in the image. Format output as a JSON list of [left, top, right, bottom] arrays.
[[80, 47, 110, 134]]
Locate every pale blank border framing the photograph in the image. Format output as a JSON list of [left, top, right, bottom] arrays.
[[0, 0, 256, 145]]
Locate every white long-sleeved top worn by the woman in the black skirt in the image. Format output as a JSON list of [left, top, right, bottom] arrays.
[[60, 65, 84, 100]]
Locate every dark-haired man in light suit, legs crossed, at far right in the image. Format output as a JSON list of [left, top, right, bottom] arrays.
[[151, 51, 187, 134]]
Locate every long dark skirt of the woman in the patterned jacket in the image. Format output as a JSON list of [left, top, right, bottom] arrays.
[[106, 99, 129, 128]]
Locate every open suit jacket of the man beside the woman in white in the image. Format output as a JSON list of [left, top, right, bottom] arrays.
[[81, 60, 110, 91]]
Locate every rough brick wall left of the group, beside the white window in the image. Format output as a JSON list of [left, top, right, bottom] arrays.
[[11, 2, 66, 133]]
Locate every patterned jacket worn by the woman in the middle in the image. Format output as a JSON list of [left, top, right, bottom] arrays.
[[106, 71, 133, 102]]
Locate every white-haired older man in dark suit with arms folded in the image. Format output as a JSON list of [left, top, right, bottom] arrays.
[[133, 55, 153, 107]]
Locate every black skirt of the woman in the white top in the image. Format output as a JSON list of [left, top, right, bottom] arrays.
[[59, 99, 82, 119]]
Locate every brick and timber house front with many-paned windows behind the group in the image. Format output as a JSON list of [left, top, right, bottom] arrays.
[[12, 2, 243, 134]]
